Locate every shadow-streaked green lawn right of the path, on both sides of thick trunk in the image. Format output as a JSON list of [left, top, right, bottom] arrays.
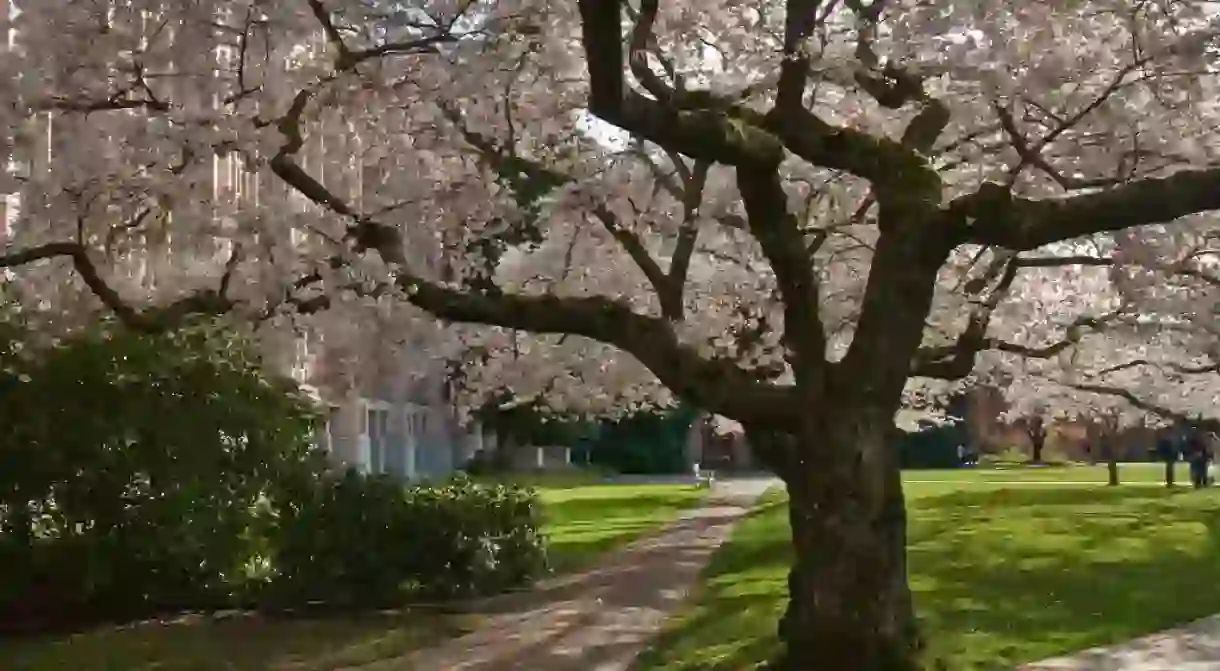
[[638, 465, 1220, 671]]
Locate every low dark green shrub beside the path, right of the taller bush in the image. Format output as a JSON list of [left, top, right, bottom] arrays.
[[270, 472, 545, 606]]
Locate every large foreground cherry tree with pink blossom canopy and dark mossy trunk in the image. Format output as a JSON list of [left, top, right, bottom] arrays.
[[7, 0, 1220, 670]]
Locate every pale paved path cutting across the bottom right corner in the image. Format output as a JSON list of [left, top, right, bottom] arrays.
[[1017, 615, 1220, 671]]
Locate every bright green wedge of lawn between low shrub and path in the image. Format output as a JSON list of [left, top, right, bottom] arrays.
[[539, 484, 708, 571]]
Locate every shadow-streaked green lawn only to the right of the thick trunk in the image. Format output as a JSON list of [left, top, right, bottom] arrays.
[[909, 488, 1220, 670]]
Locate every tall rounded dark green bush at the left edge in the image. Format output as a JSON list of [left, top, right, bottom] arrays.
[[0, 325, 317, 628]]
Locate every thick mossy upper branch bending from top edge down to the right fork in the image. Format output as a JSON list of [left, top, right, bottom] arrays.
[[580, 0, 947, 224]]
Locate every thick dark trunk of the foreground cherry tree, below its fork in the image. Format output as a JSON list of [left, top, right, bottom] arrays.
[[756, 425, 920, 671]]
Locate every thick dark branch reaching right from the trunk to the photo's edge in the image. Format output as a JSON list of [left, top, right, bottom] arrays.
[[942, 167, 1220, 250]]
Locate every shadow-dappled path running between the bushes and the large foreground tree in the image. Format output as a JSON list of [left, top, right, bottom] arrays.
[[392, 478, 777, 671]]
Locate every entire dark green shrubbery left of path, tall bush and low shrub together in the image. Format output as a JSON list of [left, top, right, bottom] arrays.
[[0, 322, 545, 632]]
